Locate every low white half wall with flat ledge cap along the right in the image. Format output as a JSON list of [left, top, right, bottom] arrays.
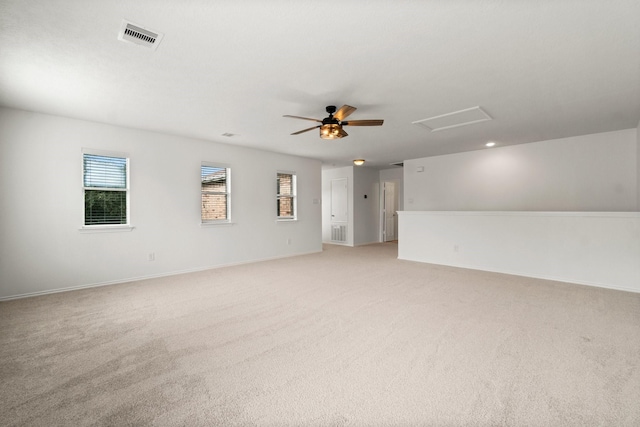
[[398, 211, 640, 292]]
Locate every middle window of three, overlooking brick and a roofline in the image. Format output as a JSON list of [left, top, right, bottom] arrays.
[[200, 163, 231, 223]]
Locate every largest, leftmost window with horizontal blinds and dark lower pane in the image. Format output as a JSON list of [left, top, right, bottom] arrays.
[[83, 153, 129, 226]]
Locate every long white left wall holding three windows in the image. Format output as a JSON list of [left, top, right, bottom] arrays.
[[0, 108, 322, 298]]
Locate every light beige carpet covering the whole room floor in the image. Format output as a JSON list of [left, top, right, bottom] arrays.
[[0, 243, 640, 426]]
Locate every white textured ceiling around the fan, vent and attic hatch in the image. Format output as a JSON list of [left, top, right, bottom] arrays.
[[0, 0, 640, 168]]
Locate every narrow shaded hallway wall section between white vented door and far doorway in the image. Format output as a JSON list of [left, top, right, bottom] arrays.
[[353, 167, 380, 246]]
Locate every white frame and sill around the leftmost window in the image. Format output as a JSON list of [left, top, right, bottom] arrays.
[[80, 148, 134, 231]]
